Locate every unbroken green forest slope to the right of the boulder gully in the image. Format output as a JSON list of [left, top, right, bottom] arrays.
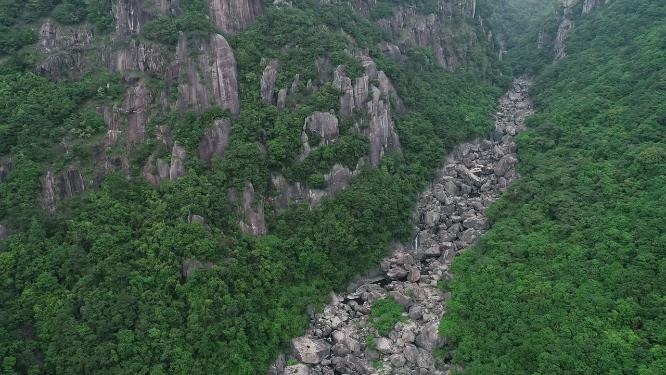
[[441, 0, 666, 375]]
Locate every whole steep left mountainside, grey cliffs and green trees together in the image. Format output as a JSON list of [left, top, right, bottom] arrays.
[[0, 0, 510, 374]]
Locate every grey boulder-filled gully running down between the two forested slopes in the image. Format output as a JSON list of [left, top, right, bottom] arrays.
[[269, 78, 532, 375]]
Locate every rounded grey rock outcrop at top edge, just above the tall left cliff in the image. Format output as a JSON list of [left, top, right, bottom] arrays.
[[208, 0, 263, 34]]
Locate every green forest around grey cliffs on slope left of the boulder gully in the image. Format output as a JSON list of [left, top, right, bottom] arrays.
[[0, 0, 510, 374]]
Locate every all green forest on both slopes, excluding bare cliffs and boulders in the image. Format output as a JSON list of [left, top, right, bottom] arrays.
[[0, 0, 666, 375]]
